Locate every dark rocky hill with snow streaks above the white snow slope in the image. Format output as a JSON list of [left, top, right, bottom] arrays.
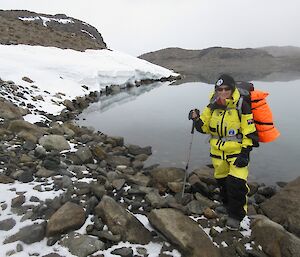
[[0, 10, 107, 51]]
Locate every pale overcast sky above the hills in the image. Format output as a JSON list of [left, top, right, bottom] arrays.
[[0, 0, 300, 56]]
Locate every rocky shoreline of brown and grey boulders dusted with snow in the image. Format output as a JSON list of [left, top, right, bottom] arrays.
[[0, 78, 300, 257]]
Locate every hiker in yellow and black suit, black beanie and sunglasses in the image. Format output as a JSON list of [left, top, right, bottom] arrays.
[[190, 74, 258, 229]]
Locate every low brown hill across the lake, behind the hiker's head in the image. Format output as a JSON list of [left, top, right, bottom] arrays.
[[140, 47, 300, 83]]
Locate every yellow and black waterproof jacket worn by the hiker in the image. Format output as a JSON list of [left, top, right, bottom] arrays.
[[195, 89, 257, 160]]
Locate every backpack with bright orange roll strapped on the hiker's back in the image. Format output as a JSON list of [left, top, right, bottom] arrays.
[[236, 81, 280, 143]]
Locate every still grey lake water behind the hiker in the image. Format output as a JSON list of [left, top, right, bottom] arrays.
[[77, 80, 300, 184]]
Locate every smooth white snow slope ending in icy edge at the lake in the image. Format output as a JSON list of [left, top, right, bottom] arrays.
[[0, 45, 178, 114]]
